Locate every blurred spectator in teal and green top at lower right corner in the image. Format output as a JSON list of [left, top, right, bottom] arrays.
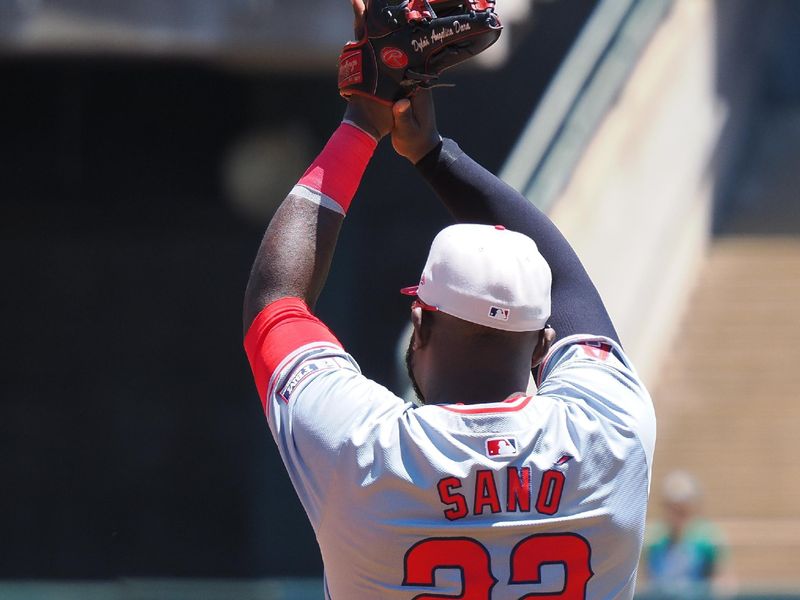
[[642, 471, 731, 599]]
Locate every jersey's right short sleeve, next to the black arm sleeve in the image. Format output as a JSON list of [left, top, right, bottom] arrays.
[[539, 335, 656, 468]]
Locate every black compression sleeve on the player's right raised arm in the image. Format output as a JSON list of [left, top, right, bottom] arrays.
[[417, 138, 619, 342]]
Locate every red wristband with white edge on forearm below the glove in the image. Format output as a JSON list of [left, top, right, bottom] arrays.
[[292, 123, 378, 215]]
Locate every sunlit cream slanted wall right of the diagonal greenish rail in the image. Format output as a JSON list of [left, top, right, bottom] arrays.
[[551, 0, 760, 382]]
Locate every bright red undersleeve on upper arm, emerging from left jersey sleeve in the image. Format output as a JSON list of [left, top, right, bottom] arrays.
[[244, 298, 342, 406]]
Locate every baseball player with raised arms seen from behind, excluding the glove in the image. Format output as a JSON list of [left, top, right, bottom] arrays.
[[244, 4, 655, 600]]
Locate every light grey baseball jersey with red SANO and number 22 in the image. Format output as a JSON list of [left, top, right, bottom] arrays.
[[245, 302, 655, 600]]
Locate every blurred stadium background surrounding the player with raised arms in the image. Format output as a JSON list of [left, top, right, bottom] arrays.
[[0, 0, 800, 600]]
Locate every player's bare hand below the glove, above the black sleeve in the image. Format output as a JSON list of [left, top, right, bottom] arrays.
[[392, 89, 442, 164]]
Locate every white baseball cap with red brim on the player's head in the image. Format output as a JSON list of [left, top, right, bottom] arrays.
[[401, 224, 552, 331]]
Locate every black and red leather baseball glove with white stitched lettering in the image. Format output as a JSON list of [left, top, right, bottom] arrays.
[[339, 0, 503, 104]]
